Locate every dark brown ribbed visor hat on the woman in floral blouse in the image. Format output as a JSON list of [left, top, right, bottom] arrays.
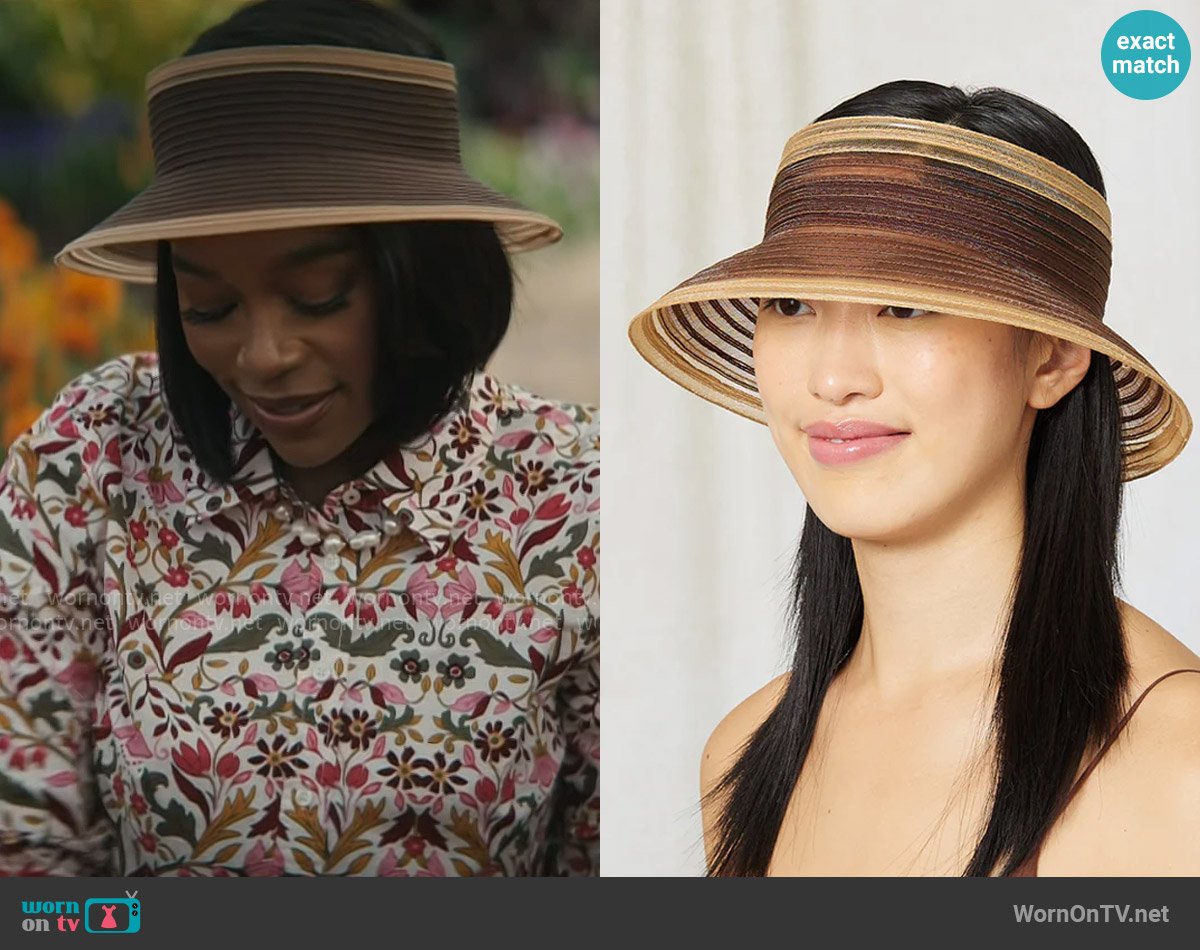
[[55, 46, 562, 283]]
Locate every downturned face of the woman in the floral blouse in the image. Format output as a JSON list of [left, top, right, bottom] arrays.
[[172, 228, 376, 469]]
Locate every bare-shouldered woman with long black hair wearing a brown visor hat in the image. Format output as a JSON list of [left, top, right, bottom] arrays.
[[630, 80, 1200, 876]]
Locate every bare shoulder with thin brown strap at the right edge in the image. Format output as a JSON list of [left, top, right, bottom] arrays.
[[1085, 603, 1200, 876]]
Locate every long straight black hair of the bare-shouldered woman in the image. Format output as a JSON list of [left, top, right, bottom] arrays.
[[708, 80, 1129, 876]]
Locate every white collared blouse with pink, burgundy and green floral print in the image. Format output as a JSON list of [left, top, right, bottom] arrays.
[[0, 354, 600, 877]]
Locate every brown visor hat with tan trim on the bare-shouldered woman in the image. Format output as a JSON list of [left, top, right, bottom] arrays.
[[629, 116, 1192, 481]]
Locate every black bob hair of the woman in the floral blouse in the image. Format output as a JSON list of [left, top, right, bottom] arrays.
[[155, 0, 514, 482]]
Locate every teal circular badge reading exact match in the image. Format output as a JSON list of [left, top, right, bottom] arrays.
[[1100, 10, 1192, 100]]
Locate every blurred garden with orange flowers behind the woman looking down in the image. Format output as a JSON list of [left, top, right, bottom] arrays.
[[0, 0, 600, 458]]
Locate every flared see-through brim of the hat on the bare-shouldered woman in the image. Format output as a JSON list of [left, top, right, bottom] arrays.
[[629, 227, 1192, 481]]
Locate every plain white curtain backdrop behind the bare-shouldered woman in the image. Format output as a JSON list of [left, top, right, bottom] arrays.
[[601, 0, 1200, 876]]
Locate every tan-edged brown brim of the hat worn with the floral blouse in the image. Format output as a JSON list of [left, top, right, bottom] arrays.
[[54, 155, 563, 283]]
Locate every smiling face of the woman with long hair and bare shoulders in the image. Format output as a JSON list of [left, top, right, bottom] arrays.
[[754, 300, 1090, 541]]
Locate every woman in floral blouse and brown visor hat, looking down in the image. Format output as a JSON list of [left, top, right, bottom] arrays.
[[0, 0, 599, 876]]
